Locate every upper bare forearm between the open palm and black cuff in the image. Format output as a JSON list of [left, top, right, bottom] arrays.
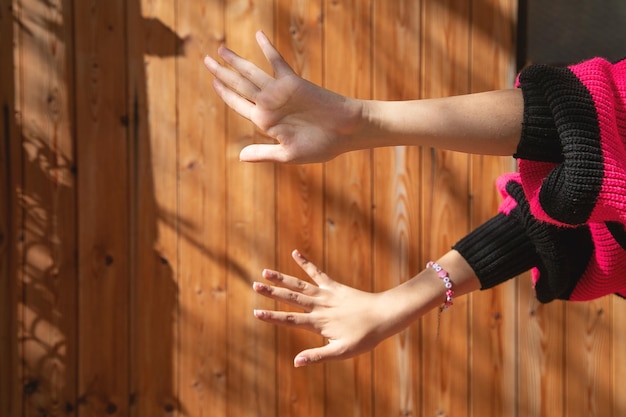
[[349, 89, 524, 155]]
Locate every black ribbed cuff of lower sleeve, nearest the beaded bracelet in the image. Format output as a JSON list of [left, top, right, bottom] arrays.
[[453, 213, 540, 289]]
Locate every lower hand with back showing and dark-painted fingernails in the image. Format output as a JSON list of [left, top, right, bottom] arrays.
[[253, 251, 398, 367]]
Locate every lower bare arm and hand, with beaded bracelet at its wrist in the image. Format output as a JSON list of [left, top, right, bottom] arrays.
[[253, 251, 480, 367]]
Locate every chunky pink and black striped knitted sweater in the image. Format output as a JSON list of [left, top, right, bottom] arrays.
[[454, 58, 626, 302]]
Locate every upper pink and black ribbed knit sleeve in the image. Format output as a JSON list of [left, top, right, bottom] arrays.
[[516, 59, 626, 226]]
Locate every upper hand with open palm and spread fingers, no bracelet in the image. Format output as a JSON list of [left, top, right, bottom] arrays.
[[204, 32, 362, 163]]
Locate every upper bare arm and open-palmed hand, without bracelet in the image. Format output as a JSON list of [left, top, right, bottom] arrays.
[[205, 32, 523, 163]]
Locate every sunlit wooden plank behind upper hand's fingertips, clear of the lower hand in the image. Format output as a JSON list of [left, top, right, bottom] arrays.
[[177, 0, 228, 417]]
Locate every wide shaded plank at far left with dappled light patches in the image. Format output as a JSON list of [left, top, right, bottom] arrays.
[[17, 0, 77, 416]]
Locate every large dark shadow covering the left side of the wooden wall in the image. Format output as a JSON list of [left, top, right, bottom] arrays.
[[0, 0, 183, 416]]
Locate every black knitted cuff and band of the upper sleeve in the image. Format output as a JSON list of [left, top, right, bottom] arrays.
[[514, 65, 604, 225]]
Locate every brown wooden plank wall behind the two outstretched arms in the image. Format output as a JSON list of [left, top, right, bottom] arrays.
[[0, 0, 626, 417]]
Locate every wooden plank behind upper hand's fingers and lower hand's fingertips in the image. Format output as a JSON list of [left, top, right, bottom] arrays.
[[225, 0, 277, 417]]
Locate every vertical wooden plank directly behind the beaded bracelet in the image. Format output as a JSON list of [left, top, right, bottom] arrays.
[[421, 0, 470, 416]]
